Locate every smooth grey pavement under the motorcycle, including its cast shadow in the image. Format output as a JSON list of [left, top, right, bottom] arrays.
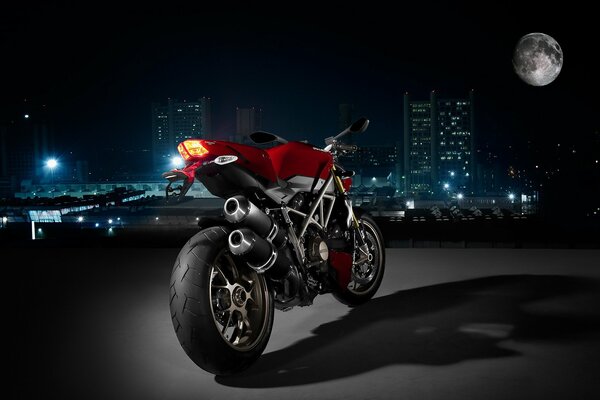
[[8, 248, 600, 400]]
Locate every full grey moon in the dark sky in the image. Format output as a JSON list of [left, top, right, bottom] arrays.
[[513, 33, 563, 86]]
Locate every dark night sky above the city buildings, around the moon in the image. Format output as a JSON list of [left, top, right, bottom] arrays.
[[0, 2, 600, 161]]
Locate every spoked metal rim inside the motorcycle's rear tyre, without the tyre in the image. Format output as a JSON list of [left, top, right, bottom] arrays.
[[209, 250, 271, 351]]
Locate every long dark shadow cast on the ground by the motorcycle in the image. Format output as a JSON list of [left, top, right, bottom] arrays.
[[215, 275, 600, 388]]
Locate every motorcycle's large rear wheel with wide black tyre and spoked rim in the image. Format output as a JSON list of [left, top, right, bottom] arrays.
[[170, 227, 274, 375]]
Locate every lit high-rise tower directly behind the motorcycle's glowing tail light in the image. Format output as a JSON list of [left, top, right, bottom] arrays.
[[152, 97, 211, 171]]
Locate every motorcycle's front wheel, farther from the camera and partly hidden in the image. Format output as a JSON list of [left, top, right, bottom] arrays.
[[333, 214, 385, 306]]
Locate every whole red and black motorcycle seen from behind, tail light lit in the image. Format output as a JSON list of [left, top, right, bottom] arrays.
[[163, 118, 385, 375]]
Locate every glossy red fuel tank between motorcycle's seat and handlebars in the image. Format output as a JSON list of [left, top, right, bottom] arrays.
[[266, 142, 333, 180]]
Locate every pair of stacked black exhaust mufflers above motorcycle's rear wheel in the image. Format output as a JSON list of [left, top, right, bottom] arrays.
[[223, 196, 292, 277]]
